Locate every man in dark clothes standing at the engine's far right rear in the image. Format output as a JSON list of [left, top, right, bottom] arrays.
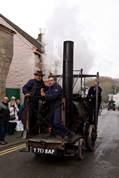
[[87, 80, 102, 122]]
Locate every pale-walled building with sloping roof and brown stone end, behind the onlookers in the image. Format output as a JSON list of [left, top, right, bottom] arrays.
[[0, 14, 44, 98]]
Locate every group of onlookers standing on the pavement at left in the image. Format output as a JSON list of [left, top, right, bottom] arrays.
[[0, 96, 22, 145]]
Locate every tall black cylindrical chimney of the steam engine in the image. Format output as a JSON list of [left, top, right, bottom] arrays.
[[63, 41, 74, 127]]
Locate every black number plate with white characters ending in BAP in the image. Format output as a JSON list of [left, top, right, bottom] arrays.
[[31, 148, 56, 155]]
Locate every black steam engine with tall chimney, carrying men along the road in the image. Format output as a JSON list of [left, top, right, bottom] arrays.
[[26, 41, 99, 159]]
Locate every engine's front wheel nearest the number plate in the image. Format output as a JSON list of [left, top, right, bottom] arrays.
[[76, 138, 85, 160]]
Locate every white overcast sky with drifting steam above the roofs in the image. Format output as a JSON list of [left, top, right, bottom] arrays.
[[0, 0, 119, 78]]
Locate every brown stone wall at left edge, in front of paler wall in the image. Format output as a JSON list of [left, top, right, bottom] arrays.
[[0, 24, 14, 98]]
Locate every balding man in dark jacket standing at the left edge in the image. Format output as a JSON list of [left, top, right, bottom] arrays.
[[0, 96, 10, 145]]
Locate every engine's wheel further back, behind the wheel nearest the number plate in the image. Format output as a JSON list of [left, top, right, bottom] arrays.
[[87, 125, 97, 151]]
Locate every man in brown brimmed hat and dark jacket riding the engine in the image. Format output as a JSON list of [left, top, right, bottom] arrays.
[[22, 71, 45, 135]]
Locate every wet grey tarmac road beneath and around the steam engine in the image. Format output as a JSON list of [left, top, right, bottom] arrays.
[[0, 110, 119, 178]]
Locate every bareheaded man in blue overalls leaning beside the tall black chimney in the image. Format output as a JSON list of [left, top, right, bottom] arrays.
[[41, 76, 72, 137]]
